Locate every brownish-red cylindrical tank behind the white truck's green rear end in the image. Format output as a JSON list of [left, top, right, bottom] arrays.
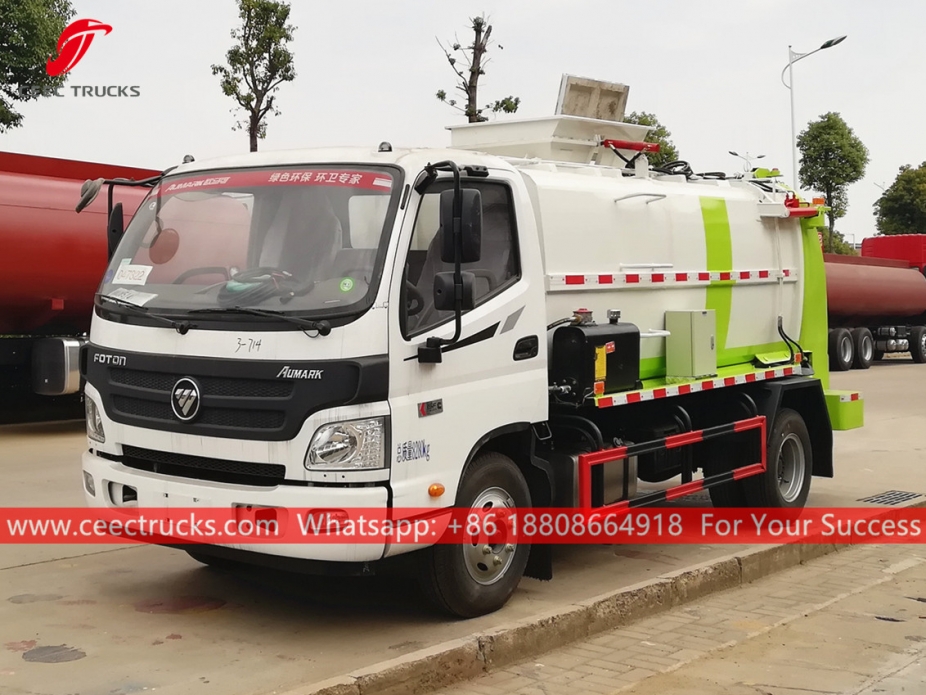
[[824, 254, 926, 319]]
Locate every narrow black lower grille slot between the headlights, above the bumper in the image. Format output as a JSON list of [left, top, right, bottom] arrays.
[[122, 446, 286, 486]]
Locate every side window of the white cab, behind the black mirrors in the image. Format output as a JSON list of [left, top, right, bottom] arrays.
[[402, 180, 521, 337]]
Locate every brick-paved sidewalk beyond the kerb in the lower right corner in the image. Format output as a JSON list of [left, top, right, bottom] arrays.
[[440, 546, 926, 695]]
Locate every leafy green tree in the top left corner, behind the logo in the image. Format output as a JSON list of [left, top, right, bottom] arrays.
[[0, 0, 74, 133]]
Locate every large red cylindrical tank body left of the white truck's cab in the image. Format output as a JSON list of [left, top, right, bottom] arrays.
[[0, 152, 160, 335]]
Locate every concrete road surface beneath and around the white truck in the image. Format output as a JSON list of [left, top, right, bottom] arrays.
[[0, 363, 926, 695]]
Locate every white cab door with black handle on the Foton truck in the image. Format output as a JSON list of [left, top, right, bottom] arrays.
[[390, 172, 547, 507]]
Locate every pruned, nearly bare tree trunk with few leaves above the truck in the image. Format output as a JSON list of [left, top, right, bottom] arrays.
[[437, 15, 521, 123]]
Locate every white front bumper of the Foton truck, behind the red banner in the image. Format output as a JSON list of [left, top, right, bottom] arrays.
[[81, 451, 388, 562]]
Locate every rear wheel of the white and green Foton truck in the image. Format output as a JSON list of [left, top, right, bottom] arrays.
[[742, 408, 813, 509]]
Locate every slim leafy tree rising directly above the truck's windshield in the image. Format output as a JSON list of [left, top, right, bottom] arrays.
[[212, 0, 296, 152]]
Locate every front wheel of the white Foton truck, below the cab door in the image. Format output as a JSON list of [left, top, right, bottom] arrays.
[[418, 451, 531, 618]]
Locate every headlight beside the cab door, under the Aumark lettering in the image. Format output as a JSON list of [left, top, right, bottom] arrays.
[[305, 417, 385, 471]]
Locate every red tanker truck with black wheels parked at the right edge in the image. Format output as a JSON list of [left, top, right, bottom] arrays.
[[824, 234, 926, 371]]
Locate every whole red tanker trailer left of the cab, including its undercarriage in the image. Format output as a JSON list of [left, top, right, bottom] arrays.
[[0, 152, 160, 419]]
